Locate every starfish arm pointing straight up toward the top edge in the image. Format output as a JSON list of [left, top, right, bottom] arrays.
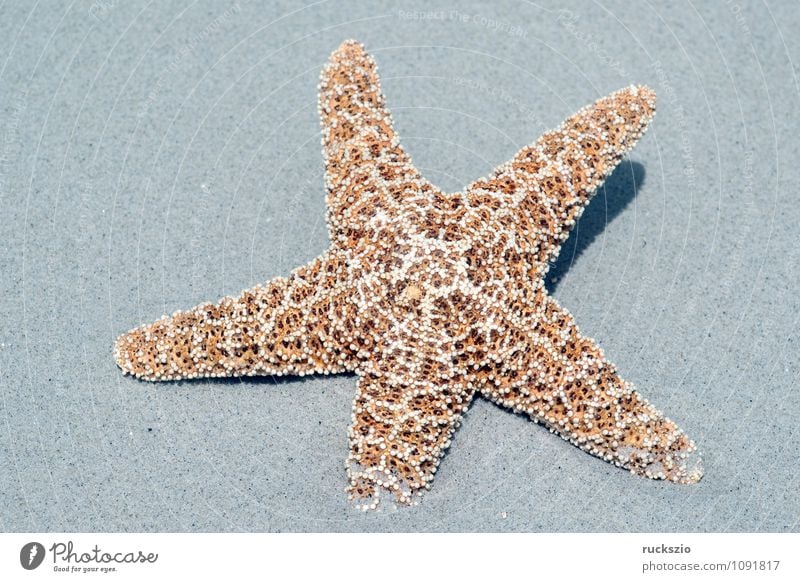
[[319, 41, 430, 240]]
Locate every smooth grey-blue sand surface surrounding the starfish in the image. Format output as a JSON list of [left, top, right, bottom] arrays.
[[0, 0, 800, 531]]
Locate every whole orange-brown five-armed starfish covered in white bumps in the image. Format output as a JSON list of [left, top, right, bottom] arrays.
[[114, 41, 702, 509]]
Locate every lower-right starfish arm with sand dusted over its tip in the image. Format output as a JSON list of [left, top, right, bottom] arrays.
[[481, 295, 703, 483]]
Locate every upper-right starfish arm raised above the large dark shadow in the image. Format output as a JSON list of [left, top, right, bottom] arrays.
[[467, 86, 656, 265]]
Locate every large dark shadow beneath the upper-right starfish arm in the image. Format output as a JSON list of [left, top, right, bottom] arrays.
[[545, 160, 645, 292]]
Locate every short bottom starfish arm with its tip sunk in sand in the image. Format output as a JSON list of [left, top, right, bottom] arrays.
[[346, 370, 475, 509]]
